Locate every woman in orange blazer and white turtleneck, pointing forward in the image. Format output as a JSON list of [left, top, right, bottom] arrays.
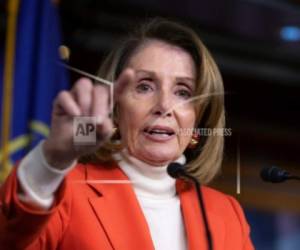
[[0, 19, 253, 250]]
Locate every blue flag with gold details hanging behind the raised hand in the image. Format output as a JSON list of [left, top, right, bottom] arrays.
[[0, 0, 69, 174]]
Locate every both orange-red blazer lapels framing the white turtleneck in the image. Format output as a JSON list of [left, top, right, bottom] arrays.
[[86, 164, 224, 250]]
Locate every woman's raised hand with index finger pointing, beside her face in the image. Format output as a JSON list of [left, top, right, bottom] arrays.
[[43, 69, 134, 169]]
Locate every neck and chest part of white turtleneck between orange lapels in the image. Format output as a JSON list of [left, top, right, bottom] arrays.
[[115, 150, 186, 250]]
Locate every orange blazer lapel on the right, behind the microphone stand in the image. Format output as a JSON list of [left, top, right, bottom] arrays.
[[176, 180, 225, 250]]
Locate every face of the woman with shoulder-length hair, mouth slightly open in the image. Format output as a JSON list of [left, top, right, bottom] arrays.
[[118, 41, 196, 166]]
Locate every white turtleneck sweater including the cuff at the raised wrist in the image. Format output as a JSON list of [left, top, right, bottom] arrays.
[[17, 144, 187, 250]]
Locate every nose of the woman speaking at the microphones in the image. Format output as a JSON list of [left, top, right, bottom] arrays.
[[153, 89, 173, 117]]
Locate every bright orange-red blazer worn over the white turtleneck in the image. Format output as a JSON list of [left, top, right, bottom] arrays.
[[0, 164, 254, 250]]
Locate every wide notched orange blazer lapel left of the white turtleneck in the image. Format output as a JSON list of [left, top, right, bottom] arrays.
[[86, 165, 154, 250]]
